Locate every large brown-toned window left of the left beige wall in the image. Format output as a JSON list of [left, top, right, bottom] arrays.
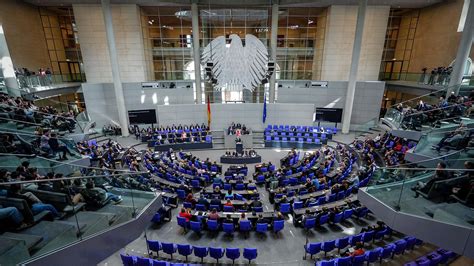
[[40, 7, 85, 81]]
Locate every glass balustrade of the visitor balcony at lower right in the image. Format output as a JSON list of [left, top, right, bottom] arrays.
[[367, 165, 474, 228]]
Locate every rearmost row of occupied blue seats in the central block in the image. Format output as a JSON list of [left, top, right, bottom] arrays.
[[176, 217, 285, 235]]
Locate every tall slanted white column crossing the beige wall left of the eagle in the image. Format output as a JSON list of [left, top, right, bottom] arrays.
[[101, 0, 128, 137]]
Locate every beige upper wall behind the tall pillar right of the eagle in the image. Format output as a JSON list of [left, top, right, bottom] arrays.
[[321, 5, 390, 81]]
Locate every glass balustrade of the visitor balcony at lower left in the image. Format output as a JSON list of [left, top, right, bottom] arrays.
[[0, 154, 156, 265]]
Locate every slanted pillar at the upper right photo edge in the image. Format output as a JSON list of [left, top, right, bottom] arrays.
[[447, 0, 474, 96]]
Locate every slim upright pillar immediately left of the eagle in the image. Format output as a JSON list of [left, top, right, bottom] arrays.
[[191, 3, 202, 104]]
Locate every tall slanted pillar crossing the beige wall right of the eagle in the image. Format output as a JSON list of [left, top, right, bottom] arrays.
[[342, 0, 367, 134]]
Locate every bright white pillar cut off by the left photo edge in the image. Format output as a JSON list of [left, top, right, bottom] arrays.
[[0, 24, 21, 97]]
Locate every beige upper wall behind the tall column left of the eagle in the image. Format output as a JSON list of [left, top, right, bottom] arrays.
[[73, 4, 149, 83]]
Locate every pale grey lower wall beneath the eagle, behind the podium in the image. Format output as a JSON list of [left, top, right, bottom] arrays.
[[82, 81, 385, 130]]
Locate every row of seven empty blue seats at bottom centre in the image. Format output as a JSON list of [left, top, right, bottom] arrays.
[[147, 240, 258, 263]]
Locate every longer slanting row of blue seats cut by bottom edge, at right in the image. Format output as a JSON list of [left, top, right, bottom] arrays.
[[315, 236, 423, 266]]
